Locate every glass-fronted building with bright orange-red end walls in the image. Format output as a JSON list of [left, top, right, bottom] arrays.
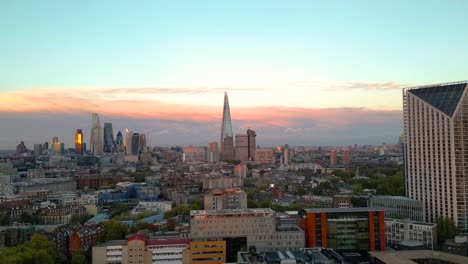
[[299, 207, 385, 251]]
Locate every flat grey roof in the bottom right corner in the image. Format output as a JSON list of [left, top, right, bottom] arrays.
[[369, 250, 468, 264]]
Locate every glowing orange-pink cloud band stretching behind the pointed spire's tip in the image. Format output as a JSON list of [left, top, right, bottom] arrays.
[[0, 88, 400, 127]]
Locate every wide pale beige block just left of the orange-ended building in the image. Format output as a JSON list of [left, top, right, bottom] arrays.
[[190, 208, 305, 262]]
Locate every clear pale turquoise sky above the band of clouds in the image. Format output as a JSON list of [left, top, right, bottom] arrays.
[[0, 0, 468, 91]]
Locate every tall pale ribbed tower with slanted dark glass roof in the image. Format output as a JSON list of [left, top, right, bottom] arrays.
[[403, 82, 468, 233]]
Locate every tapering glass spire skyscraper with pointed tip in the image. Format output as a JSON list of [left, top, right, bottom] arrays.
[[220, 92, 235, 160]]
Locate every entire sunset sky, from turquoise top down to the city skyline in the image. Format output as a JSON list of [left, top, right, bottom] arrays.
[[0, 0, 468, 149]]
